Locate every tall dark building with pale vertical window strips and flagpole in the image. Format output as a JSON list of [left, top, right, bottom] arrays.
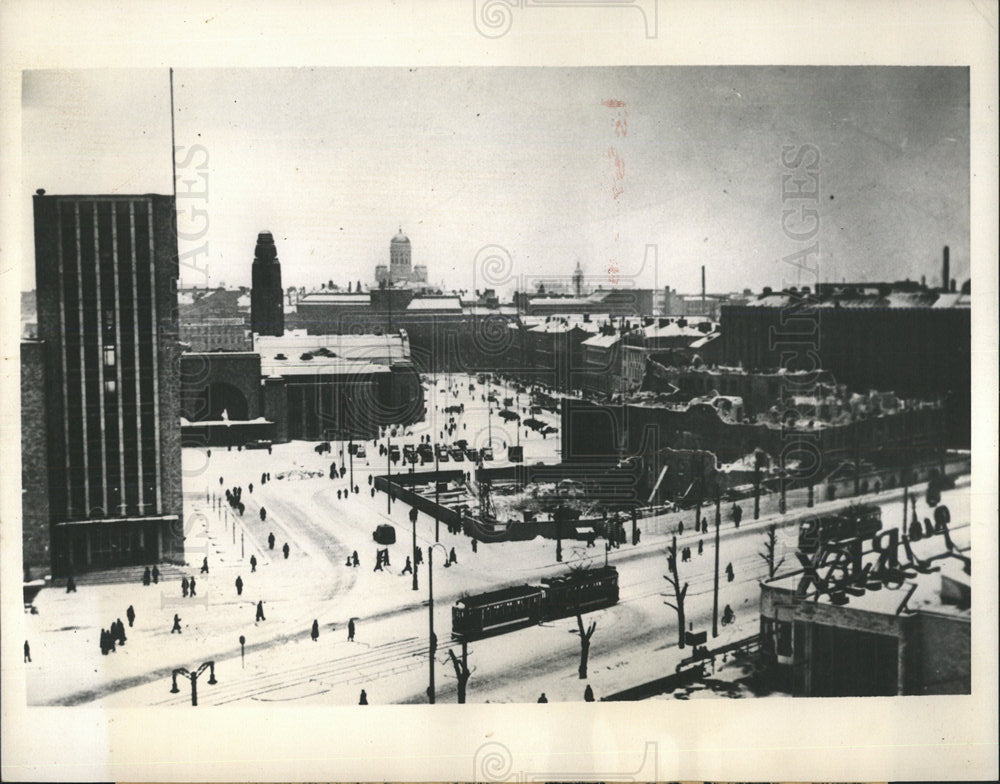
[[25, 191, 184, 575]]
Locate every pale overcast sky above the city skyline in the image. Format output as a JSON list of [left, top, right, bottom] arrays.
[[23, 67, 969, 292]]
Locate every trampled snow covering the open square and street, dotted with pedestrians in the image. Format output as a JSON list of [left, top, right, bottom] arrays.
[[25, 375, 969, 706]]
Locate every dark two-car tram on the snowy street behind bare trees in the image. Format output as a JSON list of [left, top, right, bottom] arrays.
[[451, 566, 618, 641]]
